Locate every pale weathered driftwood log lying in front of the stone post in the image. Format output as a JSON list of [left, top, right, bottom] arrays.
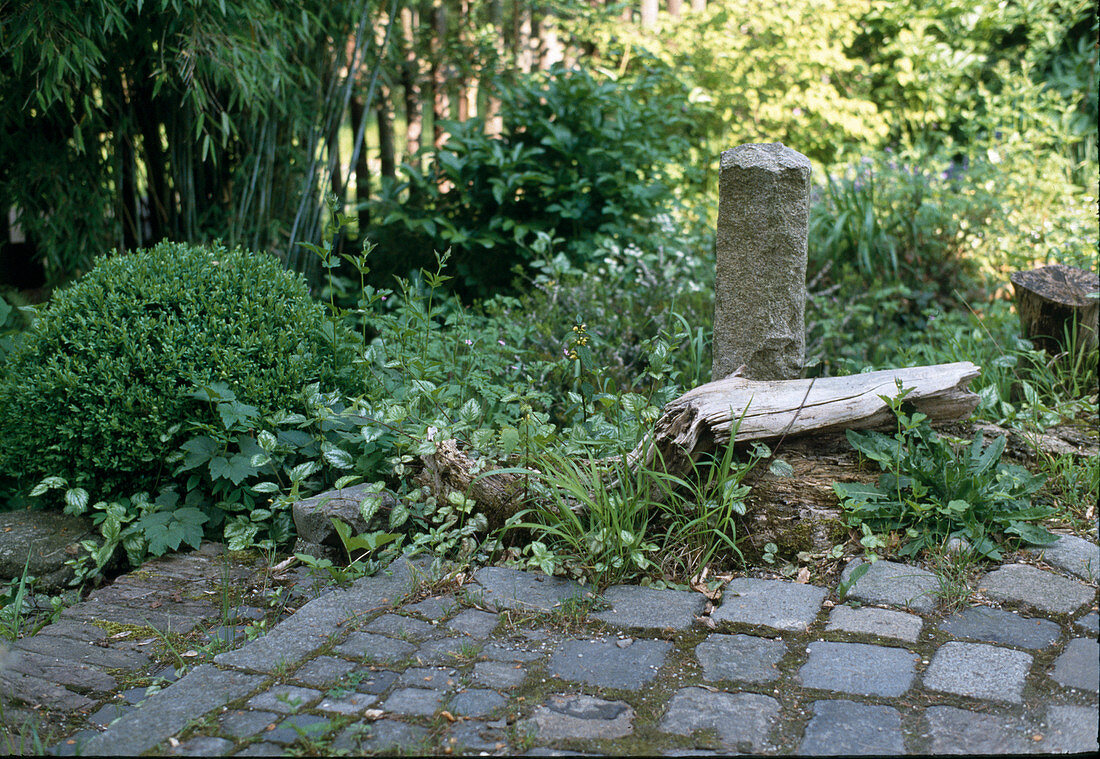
[[630, 362, 980, 470]]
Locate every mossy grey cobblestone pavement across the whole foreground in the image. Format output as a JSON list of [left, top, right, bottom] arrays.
[[0, 537, 1100, 756]]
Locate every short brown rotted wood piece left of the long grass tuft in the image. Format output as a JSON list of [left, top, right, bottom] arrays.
[[418, 440, 526, 530]]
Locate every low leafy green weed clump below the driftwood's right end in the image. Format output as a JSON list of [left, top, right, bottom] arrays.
[[833, 384, 1056, 559]]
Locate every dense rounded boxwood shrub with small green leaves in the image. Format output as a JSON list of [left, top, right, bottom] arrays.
[[0, 243, 355, 498]]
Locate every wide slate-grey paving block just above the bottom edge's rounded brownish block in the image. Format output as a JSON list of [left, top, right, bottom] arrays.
[[547, 640, 672, 691]]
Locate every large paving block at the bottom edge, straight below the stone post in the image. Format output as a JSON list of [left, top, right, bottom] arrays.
[[658, 688, 779, 752]]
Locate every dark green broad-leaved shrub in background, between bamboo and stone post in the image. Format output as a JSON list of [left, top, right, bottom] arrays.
[[371, 66, 688, 295]]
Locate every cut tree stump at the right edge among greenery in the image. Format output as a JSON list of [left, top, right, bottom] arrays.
[[1010, 264, 1100, 355]]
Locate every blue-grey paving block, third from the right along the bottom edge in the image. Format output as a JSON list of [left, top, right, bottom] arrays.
[[799, 701, 905, 757]]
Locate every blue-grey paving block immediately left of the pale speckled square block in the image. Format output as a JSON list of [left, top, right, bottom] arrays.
[[798, 640, 920, 697]]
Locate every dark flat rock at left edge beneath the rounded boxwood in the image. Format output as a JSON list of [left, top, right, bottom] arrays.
[[0, 509, 103, 593]]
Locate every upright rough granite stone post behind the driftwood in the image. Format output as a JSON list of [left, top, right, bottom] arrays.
[[712, 143, 810, 380]]
